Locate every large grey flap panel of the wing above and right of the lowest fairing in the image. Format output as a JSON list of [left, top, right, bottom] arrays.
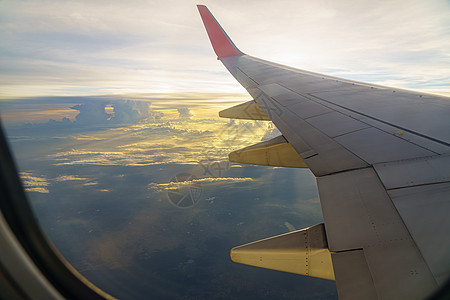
[[317, 168, 438, 299]]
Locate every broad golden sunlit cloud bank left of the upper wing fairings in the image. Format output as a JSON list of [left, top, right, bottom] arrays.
[[44, 112, 265, 166]]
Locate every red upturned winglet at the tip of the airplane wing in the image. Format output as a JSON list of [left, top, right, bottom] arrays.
[[197, 5, 244, 58]]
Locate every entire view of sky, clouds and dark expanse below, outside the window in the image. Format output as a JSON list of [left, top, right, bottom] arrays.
[[0, 0, 450, 300]]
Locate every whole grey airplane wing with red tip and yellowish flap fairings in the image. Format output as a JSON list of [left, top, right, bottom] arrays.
[[198, 5, 450, 299]]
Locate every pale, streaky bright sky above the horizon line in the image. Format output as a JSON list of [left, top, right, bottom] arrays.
[[0, 0, 450, 99]]
